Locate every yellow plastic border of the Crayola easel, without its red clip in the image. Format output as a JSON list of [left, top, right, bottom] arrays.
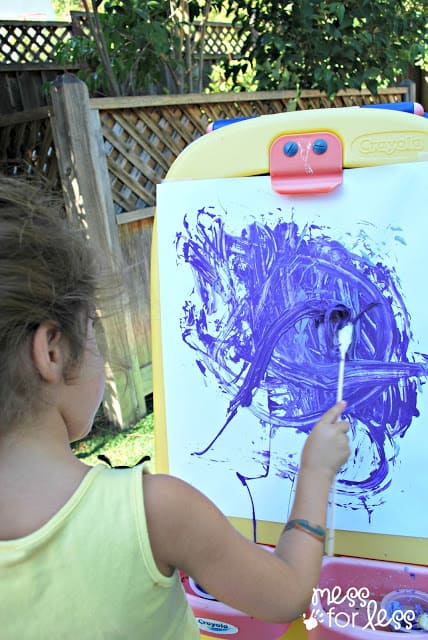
[[151, 107, 428, 568]]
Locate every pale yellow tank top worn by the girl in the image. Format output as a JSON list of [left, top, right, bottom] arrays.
[[0, 465, 199, 640]]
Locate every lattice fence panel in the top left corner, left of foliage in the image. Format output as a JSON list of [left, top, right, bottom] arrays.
[[0, 21, 71, 64]]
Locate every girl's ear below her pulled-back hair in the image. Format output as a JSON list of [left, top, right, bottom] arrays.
[[32, 321, 64, 383]]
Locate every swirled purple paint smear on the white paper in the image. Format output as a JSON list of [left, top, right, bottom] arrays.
[[176, 207, 428, 519]]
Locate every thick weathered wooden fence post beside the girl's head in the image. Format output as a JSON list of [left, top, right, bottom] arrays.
[[51, 74, 147, 428]]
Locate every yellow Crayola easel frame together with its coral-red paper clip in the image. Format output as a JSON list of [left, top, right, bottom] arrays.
[[152, 108, 428, 640]]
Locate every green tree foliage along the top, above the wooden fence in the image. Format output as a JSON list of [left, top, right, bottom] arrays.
[[56, 0, 428, 96]]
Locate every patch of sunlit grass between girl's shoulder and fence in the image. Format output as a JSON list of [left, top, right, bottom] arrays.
[[72, 413, 154, 469]]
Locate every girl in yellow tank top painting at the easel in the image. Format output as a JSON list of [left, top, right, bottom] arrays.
[[0, 178, 349, 640]]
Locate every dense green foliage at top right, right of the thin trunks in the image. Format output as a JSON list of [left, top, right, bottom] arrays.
[[226, 0, 428, 95]]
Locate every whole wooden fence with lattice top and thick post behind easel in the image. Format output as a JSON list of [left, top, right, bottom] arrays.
[[0, 74, 407, 426]]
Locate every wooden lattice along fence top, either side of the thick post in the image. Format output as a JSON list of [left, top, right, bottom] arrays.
[[0, 80, 408, 210]]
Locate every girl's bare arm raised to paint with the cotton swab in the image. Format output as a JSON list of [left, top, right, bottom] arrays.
[[143, 403, 349, 622]]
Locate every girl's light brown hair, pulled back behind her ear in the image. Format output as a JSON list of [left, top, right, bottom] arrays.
[[0, 176, 98, 427]]
